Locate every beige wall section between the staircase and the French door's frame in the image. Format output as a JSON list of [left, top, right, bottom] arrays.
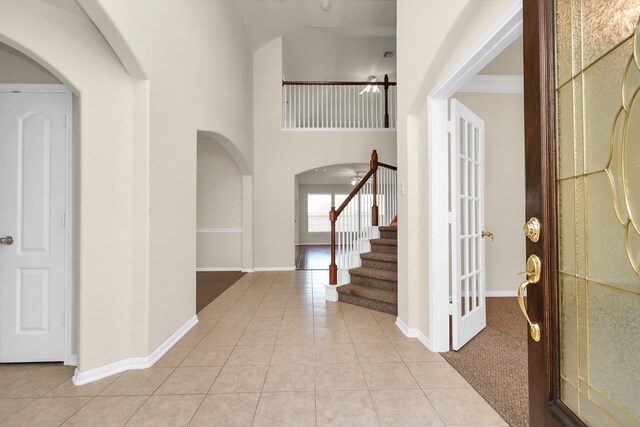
[[397, 0, 515, 340]]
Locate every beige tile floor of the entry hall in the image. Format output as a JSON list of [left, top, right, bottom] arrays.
[[0, 271, 506, 427]]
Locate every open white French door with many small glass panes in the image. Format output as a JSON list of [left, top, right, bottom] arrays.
[[450, 99, 487, 350]]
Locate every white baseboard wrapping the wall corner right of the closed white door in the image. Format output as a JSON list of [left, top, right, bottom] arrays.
[[72, 316, 198, 385]]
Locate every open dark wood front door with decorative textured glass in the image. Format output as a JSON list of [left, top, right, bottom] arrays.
[[524, 0, 640, 426]]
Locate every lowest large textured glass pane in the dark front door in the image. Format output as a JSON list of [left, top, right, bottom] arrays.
[[588, 282, 640, 423]]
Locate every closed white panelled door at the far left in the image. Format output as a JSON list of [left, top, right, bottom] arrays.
[[0, 93, 67, 362]]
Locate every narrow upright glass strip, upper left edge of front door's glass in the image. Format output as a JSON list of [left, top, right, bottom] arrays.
[[557, 83, 574, 178]]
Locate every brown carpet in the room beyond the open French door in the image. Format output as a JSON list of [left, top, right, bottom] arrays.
[[442, 298, 529, 427]]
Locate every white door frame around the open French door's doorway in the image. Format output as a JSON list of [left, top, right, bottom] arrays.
[[427, 2, 522, 352]]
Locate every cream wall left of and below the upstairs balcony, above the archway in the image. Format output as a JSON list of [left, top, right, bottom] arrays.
[[253, 38, 396, 269]]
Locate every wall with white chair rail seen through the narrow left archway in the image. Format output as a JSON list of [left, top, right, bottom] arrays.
[[196, 140, 243, 271]]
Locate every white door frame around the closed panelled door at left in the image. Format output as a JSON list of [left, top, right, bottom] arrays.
[[0, 84, 78, 366]]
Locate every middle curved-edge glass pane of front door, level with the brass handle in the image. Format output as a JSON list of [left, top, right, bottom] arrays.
[[585, 172, 640, 290]]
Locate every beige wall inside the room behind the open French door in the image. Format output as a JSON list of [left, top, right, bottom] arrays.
[[454, 93, 526, 294]]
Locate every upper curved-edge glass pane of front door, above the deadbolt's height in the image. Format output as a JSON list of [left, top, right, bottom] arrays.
[[584, 40, 633, 172]]
